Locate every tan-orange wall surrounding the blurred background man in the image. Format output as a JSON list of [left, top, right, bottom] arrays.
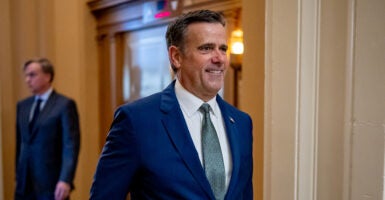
[[0, 0, 99, 199]]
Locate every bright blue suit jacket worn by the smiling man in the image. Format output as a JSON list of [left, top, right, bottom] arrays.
[[90, 81, 253, 200]]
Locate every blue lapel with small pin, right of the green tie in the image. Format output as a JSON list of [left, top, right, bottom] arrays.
[[217, 96, 241, 197]]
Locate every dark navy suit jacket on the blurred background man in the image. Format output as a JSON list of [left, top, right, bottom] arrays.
[[16, 91, 80, 194]]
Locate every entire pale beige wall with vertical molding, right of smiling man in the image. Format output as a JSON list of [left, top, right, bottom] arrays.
[[262, 0, 385, 200]]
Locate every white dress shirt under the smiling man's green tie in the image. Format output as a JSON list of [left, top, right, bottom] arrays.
[[175, 80, 232, 189]]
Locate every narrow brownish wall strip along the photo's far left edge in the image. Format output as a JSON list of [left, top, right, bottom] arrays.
[[0, 1, 16, 199]]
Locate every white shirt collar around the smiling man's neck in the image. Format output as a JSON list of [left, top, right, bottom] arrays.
[[175, 79, 219, 117]]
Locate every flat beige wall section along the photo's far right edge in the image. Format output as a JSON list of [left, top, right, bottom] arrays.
[[345, 0, 385, 200]]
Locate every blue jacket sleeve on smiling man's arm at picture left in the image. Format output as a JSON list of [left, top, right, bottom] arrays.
[[90, 108, 140, 200]]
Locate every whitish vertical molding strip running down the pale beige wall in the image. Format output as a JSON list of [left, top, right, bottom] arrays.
[[294, 0, 321, 200]]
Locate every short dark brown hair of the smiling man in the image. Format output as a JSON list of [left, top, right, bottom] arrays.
[[166, 10, 226, 72]]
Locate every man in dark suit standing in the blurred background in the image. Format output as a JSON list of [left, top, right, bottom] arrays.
[[15, 58, 80, 200]]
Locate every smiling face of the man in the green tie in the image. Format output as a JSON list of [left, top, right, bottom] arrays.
[[176, 22, 228, 101]]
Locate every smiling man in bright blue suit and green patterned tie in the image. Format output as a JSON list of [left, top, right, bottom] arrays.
[[90, 10, 253, 200]]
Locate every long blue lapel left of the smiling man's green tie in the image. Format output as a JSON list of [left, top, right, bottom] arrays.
[[161, 81, 213, 197]]
